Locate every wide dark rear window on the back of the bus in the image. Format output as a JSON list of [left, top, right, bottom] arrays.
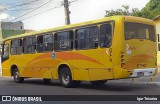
[[124, 22, 156, 41]]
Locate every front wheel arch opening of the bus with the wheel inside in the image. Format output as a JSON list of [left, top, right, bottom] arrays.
[[11, 65, 24, 83]]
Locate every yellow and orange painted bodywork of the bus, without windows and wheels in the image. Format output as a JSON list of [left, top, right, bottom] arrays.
[[2, 16, 157, 81]]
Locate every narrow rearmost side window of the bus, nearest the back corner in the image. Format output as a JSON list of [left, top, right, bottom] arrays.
[[100, 24, 112, 48]]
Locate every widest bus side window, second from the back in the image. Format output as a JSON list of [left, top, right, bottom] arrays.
[[75, 26, 98, 49]]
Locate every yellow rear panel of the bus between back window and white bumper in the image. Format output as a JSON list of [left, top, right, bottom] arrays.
[[125, 40, 157, 70]]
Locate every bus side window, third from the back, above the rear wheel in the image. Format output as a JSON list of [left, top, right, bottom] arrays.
[[54, 31, 73, 51]]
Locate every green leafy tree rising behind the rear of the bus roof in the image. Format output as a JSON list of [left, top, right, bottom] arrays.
[[105, 0, 160, 19]]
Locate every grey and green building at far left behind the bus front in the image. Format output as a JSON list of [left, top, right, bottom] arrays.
[[0, 21, 25, 43]]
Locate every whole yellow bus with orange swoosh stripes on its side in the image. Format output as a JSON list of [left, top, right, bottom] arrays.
[[2, 16, 158, 87]]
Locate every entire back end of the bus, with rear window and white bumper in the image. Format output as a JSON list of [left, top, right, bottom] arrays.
[[123, 18, 158, 77]]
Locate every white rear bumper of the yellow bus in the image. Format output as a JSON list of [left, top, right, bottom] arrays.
[[130, 68, 157, 78]]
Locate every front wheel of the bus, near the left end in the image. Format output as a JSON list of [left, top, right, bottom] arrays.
[[13, 68, 24, 83]]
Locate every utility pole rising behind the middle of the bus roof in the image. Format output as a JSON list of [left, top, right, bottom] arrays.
[[64, 0, 70, 25]]
